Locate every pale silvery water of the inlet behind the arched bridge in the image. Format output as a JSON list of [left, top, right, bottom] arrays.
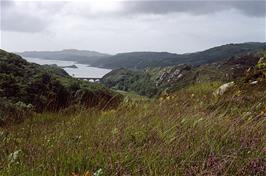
[[24, 57, 111, 78]]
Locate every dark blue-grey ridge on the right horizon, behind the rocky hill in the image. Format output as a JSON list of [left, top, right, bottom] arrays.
[[92, 42, 266, 69]]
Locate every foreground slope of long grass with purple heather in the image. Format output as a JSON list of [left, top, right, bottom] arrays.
[[0, 81, 266, 175]]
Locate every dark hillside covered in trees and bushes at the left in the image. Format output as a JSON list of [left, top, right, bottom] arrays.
[[0, 50, 121, 124]]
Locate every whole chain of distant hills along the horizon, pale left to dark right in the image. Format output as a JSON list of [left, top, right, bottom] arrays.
[[17, 42, 266, 69]]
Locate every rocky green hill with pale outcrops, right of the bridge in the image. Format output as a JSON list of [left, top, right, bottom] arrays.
[[102, 50, 266, 97]]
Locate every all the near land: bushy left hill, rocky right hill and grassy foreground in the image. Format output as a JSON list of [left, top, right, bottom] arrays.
[[0, 47, 266, 176]]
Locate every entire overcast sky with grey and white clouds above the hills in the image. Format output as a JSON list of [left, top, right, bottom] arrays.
[[0, 0, 266, 54]]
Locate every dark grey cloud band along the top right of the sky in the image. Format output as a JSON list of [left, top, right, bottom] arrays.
[[124, 0, 266, 17]]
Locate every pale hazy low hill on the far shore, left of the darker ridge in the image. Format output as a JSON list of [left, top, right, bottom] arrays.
[[16, 49, 110, 64]]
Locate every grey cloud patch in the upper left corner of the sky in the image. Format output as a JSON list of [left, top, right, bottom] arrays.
[[1, 1, 65, 33]]
